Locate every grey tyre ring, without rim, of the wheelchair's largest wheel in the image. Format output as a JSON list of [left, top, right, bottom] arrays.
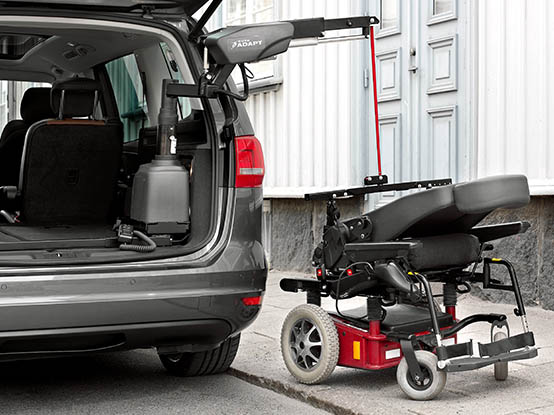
[[281, 304, 340, 385]]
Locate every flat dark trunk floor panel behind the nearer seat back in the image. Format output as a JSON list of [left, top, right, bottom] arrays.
[[0, 224, 117, 243]]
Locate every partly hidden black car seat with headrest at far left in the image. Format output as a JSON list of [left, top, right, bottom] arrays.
[[0, 88, 54, 186]]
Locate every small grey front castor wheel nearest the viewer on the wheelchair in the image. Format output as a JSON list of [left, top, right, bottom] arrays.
[[396, 350, 446, 401]]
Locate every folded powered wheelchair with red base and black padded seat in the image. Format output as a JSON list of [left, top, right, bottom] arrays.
[[280, 175, 537, 400]]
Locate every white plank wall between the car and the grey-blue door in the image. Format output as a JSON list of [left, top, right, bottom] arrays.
[[247, 0, 370, 197]]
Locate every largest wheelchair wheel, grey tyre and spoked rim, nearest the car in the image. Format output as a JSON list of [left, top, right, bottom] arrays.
[[281, 304, 339, 384]]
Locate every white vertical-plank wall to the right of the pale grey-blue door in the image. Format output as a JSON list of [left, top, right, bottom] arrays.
[[477, 0, 554, 195]]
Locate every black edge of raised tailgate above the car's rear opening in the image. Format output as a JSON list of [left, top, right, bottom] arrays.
[[1, 0, 209, 16]]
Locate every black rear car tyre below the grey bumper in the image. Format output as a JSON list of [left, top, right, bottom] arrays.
[[160, 334, 240, 377]]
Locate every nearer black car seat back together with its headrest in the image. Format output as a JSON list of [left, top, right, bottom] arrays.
[[19, 78, 123, 224]]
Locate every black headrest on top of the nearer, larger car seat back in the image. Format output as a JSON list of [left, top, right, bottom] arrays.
[[50, 78, 100, 119]]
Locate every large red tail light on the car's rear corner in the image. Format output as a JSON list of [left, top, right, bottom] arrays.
[[235, 136, 265, 187]]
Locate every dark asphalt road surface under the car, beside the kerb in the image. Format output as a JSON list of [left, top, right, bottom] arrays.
[[0, 350, 326, 415]]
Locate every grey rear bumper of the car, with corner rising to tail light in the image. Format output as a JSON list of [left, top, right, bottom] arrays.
[[0, 189, 268, 359]]
